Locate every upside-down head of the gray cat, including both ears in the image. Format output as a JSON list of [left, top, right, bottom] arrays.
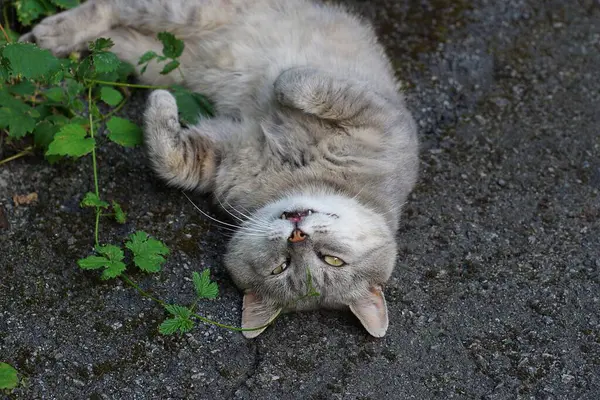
[[225, 195, 396, 337]]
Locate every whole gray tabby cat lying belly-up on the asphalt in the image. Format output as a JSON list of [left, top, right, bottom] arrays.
[[23, 0, 418, 337]]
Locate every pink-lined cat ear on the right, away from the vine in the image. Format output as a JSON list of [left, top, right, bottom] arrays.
[[350, 286, 389, 337]]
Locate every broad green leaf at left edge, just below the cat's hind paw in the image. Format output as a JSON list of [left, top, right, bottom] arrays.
[[2, 43, 60, 79]]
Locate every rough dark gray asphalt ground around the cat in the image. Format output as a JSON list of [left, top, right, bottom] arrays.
[[0, 0, 600, 400]]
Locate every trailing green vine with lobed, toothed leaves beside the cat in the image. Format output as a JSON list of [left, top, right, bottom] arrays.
[[0, 0, 318, 335]]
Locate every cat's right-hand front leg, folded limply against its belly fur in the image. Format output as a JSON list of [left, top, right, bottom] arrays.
[[274, 67, 397, 129]]
